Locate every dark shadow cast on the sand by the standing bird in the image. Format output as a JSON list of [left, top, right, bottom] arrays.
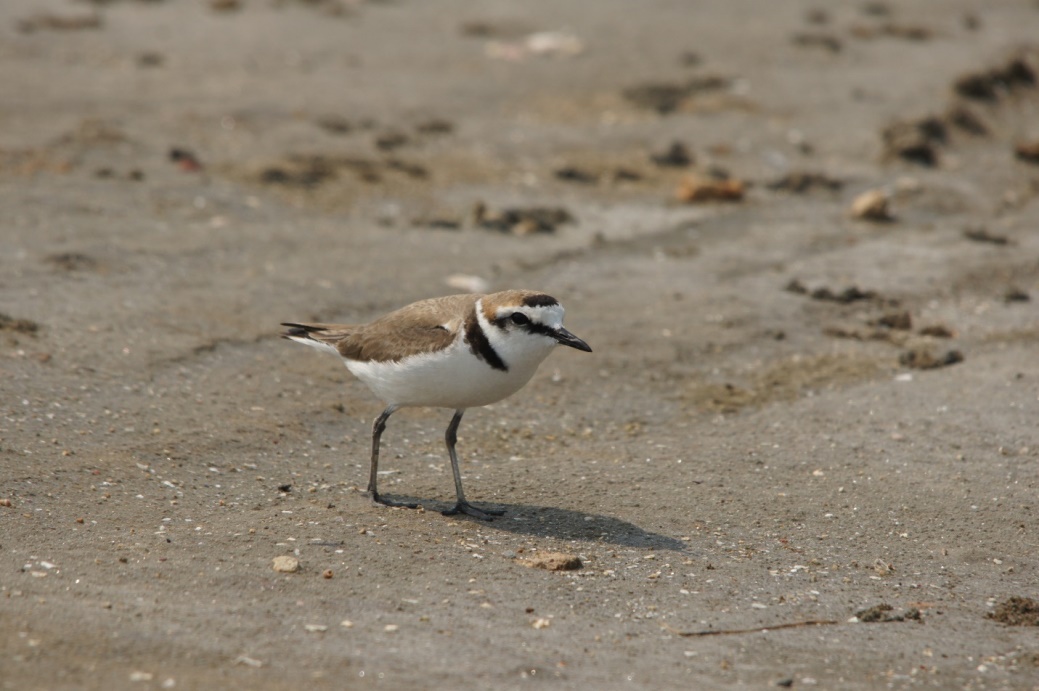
[[378, 496, 687, 552]]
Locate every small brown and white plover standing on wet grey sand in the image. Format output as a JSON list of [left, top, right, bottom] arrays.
[[282, 290, 591, 521]]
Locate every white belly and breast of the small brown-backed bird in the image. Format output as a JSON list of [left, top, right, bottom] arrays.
[[345, 339, 552, 409]]
